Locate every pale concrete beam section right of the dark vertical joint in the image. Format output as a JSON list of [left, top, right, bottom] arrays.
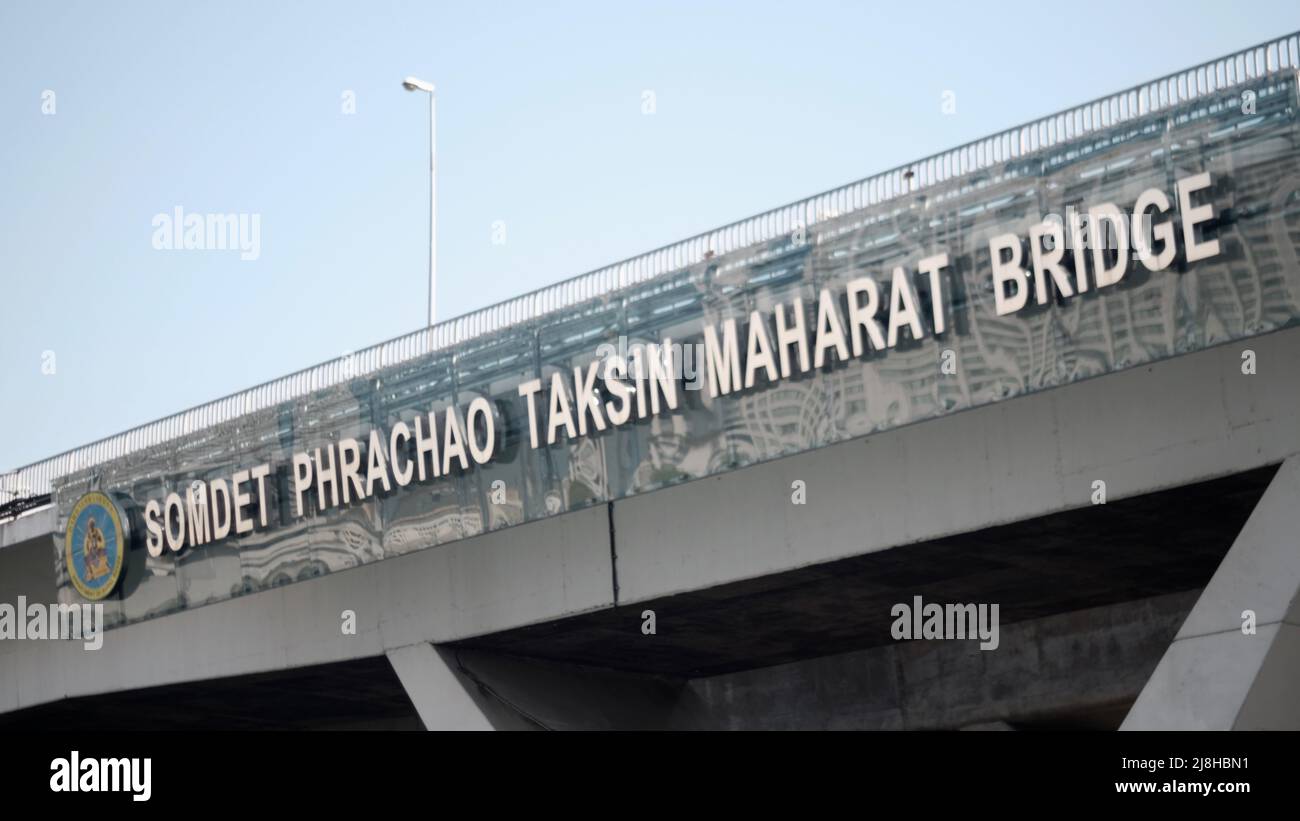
[[614, 329, 1300, 604]]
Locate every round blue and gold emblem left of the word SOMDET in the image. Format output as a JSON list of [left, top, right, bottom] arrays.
[[64, 491, 129, 601]]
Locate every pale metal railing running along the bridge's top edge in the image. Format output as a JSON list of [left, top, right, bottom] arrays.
[[0, 32, 1300, 503]]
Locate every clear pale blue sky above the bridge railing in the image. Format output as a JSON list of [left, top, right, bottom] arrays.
[[0, 0, 1300, 469]]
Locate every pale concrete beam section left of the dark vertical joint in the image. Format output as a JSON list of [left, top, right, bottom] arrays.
[[0, 505, 614, 712]]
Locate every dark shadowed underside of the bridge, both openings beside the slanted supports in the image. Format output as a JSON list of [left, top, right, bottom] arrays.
[[0, 466, 1277, 730]]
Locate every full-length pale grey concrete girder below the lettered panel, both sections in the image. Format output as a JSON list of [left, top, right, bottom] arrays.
[[0, 329, 1300, 712]]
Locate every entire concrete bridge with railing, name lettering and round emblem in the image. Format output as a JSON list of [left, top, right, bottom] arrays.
[[0, 35, 1300, 727]]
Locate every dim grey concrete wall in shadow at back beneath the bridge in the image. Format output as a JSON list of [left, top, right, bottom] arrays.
[[690, 591, 1197, 730]]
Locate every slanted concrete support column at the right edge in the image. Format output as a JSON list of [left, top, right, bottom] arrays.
[[1121, 456, 1300, 730]]
